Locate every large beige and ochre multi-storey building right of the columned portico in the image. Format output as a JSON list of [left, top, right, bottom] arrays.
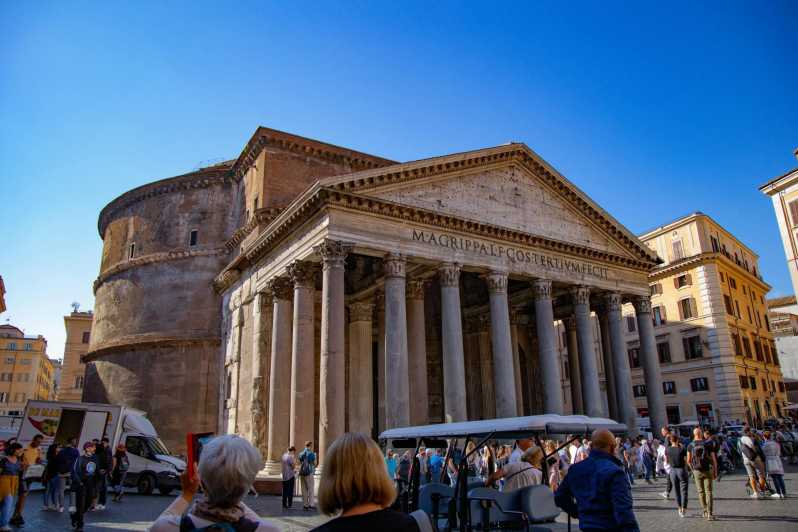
[[624, 212, 786, 424]]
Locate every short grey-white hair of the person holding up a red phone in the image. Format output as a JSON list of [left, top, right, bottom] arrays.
[[199, 434, 263, 508]]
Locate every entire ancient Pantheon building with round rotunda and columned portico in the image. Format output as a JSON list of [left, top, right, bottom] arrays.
[[84, 128, 666, 462]]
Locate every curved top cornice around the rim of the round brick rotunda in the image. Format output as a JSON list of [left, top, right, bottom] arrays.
[[97, 163, 232, 238]]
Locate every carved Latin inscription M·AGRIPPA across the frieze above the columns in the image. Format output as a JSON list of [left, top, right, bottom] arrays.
[[413, 229, 609, 279]]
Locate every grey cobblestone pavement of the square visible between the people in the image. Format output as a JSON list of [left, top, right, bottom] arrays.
[[17, 466, 798, 532]]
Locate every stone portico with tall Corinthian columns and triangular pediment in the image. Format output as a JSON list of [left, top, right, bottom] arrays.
[[214, 136, 666, 473]]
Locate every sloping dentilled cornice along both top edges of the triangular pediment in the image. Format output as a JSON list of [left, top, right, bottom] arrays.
[[322, 143, 661, 263]]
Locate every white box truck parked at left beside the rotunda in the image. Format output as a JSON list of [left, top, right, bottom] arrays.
[[17, 401, 186, 495]]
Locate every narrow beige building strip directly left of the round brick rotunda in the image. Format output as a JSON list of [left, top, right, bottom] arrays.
[[58, 310, 94, 401]]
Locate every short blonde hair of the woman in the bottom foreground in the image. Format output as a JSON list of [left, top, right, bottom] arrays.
[[318, 432, 396, 515]]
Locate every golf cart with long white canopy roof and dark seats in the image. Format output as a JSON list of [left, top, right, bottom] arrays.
[[380, 414, 627, 532]]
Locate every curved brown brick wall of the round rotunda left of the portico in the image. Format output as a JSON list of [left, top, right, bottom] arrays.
[[83, 165, 240, 452]]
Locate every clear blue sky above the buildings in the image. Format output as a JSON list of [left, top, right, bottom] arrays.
[[0, 1, 798, 357]]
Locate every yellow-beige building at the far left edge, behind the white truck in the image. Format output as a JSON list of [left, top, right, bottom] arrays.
[[0, 325, 55, 415]]
